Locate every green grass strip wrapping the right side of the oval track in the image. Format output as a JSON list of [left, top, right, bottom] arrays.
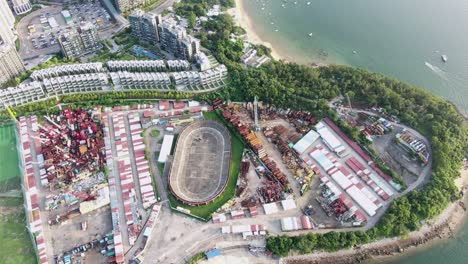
[[168, 112, 244, 221]]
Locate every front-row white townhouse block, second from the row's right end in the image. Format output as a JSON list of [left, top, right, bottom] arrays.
[[110, 71, 171, 90]]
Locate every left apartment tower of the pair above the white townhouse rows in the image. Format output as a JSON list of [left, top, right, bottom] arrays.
[[128, 9, 161, 45]]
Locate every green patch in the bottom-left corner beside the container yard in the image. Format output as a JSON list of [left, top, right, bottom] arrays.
[[0, 198, 37, 264]]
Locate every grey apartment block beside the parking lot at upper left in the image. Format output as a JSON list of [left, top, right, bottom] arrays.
[[59, 22, 102, 59]]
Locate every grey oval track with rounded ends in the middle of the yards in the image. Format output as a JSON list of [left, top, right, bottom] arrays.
[[169, 120, 231, 205]]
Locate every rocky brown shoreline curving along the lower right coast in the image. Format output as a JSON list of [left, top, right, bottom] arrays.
[[283, 169, 468, 264]]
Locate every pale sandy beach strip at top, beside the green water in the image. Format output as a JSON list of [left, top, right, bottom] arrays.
[[231, 0, 285, 60]]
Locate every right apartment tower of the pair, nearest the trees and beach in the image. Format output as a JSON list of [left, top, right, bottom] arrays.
[[158, 18, 200, 60]]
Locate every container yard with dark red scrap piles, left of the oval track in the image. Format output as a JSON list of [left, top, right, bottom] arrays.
[[18, 101, 208, 263]]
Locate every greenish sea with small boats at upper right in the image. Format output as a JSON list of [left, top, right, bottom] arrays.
[[242, 0, 468, 115]]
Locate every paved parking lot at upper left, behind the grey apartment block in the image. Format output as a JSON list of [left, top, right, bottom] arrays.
[[17, 1, 115, 59]]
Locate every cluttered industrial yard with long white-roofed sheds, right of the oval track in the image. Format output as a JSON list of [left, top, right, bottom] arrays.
[[213, 100, 406, 230]]
